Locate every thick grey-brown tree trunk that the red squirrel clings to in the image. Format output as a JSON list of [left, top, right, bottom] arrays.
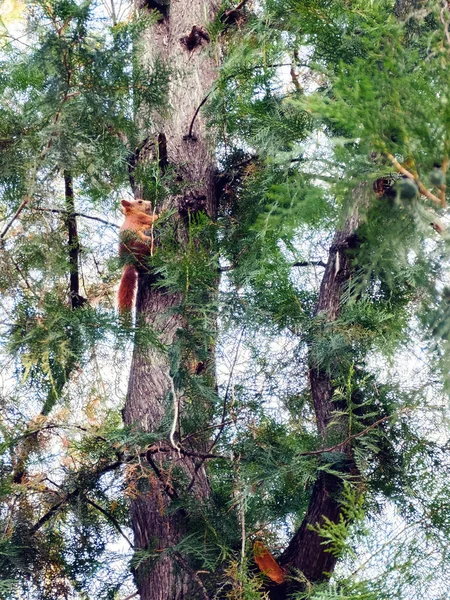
[[123, 0, 220, 600]]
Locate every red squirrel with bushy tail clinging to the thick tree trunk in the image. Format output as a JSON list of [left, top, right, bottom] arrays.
[[117, 199, 159, 312]]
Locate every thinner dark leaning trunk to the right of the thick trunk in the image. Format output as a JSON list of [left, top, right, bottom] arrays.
[[280, 186, 368, 584]]
